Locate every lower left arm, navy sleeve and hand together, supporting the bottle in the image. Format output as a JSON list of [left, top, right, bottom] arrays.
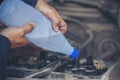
[[0, 23, 35, 80]]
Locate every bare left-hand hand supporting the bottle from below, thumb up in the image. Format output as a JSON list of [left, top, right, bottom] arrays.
[[0, 22, 35, 48]]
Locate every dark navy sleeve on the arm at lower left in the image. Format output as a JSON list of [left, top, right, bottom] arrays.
[[0, 35, 11, 80]]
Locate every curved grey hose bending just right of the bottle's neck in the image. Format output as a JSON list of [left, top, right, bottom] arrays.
[[62, 16, 94, 48]]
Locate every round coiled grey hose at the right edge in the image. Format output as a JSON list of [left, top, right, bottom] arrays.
[[98, 38, 119, 59]]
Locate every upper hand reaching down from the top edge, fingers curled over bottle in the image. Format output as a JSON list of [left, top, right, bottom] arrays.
[[36, 0, 67, 33]]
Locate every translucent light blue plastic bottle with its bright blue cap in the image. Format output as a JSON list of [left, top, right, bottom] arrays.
[[0, 0, 79, 58]]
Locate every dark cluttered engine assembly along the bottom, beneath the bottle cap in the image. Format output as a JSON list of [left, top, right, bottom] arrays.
[[8, 51, 108, 80]]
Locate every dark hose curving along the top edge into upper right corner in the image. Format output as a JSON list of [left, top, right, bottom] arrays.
[[59, 0, 117, 25]]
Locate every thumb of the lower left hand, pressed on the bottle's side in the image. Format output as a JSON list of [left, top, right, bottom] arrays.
[[20, 22, 35, 34]]
